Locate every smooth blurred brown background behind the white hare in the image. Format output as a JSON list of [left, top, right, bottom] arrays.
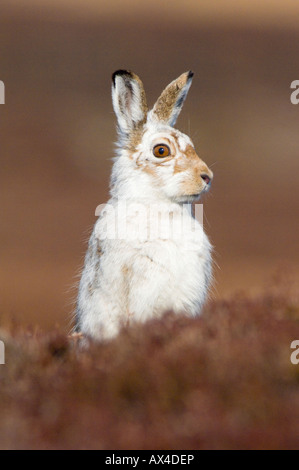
[[0, 0, 299, 328]]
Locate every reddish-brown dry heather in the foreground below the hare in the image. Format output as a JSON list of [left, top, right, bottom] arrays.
[[0, 280, 299, 450]]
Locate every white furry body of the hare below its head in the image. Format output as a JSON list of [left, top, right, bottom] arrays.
[[80, 199, 211, 337]]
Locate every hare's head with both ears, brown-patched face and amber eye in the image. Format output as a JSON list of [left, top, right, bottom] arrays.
[[112, 70, 213, 202]]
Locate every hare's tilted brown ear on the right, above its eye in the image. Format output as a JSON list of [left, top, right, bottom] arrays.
[[151, 71, 194, 126]]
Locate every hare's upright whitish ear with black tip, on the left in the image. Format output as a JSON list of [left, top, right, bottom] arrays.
[[112, 70, 147, 136]]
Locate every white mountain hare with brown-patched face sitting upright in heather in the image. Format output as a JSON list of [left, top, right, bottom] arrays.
[[76, 70, 213, 339]]
